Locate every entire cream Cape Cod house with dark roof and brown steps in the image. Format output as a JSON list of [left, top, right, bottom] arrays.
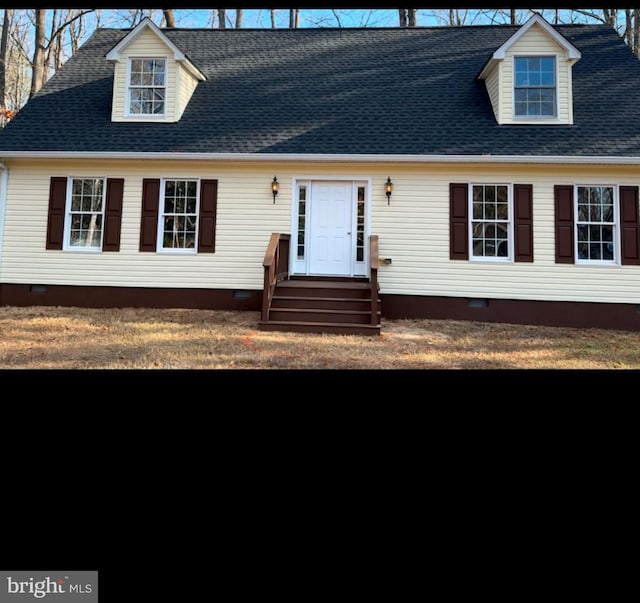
[[0, 15, 640, 334]]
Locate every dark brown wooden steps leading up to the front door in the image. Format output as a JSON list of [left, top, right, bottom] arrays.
[[258, 277, 380, 335]]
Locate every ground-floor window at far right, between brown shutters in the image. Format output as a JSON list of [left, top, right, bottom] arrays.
[[575, 185, 618, 263]]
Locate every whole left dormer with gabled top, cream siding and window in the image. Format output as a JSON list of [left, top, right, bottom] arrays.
[[106, 17, 206, 123]]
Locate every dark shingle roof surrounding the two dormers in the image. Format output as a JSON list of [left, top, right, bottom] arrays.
[[0, 25, 640, 156]]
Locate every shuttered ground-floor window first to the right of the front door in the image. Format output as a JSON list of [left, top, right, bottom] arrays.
[[469, 184, 512, 260]]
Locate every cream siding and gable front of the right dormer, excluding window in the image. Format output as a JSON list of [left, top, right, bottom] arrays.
[[500, 24, 573, 124]]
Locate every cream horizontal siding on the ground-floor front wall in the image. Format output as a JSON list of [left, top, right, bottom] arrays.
[[0, 160, 640, 303]]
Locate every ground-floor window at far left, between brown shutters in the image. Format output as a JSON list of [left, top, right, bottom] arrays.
[[64, 178, 106, 251]]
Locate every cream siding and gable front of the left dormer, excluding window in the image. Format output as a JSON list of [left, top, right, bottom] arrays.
[[111, 29, 179, 122]]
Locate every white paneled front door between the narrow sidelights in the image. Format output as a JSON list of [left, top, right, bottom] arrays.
[[308, 181, 353, 276]]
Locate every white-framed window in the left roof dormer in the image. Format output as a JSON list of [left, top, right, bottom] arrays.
[[129, 58, 167, 116]]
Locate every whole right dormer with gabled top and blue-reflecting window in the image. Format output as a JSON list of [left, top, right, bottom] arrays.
[[478, 15, 581, 125]]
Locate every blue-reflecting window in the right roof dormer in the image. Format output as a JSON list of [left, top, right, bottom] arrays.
[[513, 56, 557, 118]]
